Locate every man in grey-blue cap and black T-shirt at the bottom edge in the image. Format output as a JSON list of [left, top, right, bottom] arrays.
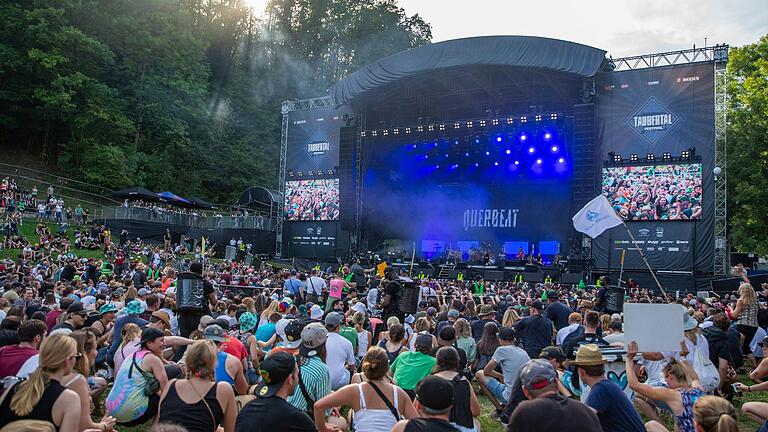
[[507, 359, 602, 432]]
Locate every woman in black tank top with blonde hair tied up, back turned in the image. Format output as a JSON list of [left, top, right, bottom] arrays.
[[158, 340, 237, 432]]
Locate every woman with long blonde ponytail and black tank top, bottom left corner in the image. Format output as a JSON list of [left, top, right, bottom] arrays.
[[0, 334, 80, 432]]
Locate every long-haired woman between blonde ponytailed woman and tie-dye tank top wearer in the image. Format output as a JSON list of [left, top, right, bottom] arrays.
[[64, 329, 115, 431]]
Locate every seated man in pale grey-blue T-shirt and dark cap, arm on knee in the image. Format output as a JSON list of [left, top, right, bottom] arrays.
[[475, 327, 538, 408]]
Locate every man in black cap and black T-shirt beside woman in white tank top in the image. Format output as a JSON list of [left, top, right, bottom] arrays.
[[235, 353, 317, 432]]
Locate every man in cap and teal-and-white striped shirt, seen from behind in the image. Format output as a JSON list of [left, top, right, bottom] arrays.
[[287, 322, 332, 417]]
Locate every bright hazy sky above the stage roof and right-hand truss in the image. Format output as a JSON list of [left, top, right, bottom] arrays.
[[398, 0, 768, 58]]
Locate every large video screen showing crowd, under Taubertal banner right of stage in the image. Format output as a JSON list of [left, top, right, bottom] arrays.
[[602, 163, 702, 221]]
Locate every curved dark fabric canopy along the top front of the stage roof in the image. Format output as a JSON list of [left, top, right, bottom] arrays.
[[329, 36, 605, 106]]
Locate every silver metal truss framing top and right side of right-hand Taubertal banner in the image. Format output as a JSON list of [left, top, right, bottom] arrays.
[[609, 44, 730, 276]]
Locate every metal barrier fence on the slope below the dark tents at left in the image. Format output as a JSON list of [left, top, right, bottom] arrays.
[[101, 207, 275, 231]]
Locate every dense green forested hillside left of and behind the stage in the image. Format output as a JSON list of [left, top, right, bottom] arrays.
[[0, 0, 431, 203]]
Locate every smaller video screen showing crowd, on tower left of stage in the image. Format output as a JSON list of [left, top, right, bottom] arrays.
[[285, 179, 339, 221]]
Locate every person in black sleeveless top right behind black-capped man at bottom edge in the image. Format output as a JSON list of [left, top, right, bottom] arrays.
[[432, 346, 480, 432]]
